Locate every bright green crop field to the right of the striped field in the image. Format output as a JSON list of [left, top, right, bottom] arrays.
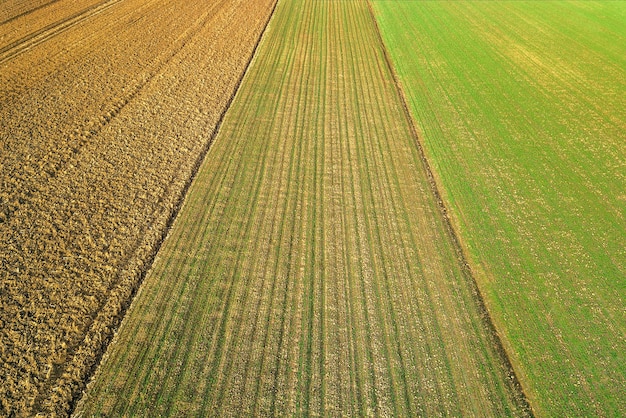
[[373, 1, 626, 416]]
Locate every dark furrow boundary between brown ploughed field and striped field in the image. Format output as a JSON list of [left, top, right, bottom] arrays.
[[49, 0, 279, 416]]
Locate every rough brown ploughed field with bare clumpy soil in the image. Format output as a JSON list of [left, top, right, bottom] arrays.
[[0, 0, 274, 416]]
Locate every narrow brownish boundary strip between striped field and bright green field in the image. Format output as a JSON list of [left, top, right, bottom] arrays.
[[365, 0, 535, 417]]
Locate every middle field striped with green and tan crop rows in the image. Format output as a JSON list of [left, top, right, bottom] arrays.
[[78, 0, 529, 416]]
